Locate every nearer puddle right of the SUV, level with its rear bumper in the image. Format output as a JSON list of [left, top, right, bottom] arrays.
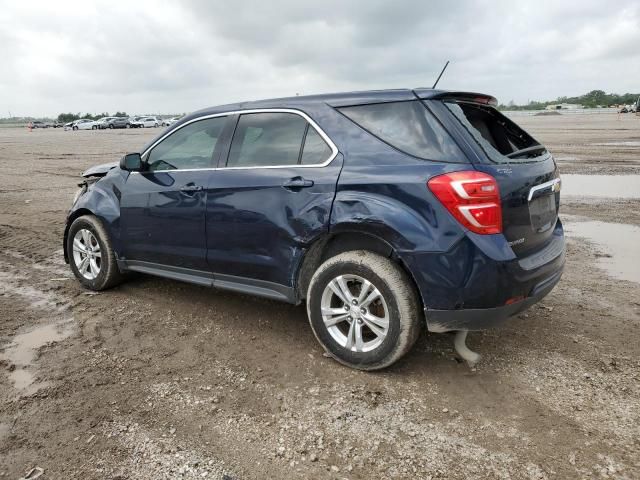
[[564, 220, 640, 283]]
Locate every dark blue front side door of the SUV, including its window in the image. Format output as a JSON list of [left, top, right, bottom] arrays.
[[120, 117, 226, 270]]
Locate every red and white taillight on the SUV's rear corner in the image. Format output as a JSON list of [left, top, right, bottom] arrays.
[[427, 171, 502, 235]]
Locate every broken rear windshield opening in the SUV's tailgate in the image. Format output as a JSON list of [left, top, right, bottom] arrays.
[[445, 101, 547, 163]]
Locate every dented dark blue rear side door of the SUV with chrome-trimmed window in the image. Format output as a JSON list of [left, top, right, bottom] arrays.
[[207, 110, 342, 287]]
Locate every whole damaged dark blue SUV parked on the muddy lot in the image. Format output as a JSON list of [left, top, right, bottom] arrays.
[[64, 89, 565, 370]]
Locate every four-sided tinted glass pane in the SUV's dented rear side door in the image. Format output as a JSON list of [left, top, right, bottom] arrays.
[[227, 113, 307, 167]]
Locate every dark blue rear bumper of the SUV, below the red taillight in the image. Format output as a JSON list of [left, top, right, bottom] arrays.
[[401, 221, 565, 332]]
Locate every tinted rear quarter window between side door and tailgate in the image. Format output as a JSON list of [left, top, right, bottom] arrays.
[[339, 100, 466, 163]]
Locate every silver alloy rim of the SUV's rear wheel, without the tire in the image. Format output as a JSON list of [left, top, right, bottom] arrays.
[[320, 275, 389, 352]]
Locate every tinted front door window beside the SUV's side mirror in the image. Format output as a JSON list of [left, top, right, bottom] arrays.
[[147, 117, 227, 171]]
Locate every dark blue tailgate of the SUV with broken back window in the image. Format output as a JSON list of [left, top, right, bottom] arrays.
[[436, 97, 560, 257]]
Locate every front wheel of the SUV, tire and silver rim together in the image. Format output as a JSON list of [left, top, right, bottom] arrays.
[[67, 215, 123, 291]]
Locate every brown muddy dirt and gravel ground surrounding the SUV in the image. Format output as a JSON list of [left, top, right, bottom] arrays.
[[0, 115, 640, 480]]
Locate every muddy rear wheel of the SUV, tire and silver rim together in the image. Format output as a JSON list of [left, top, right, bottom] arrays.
[[307, 250, 423, 370]]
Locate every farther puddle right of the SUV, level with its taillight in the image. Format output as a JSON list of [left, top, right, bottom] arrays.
[[562, 174, 640, 198]]
